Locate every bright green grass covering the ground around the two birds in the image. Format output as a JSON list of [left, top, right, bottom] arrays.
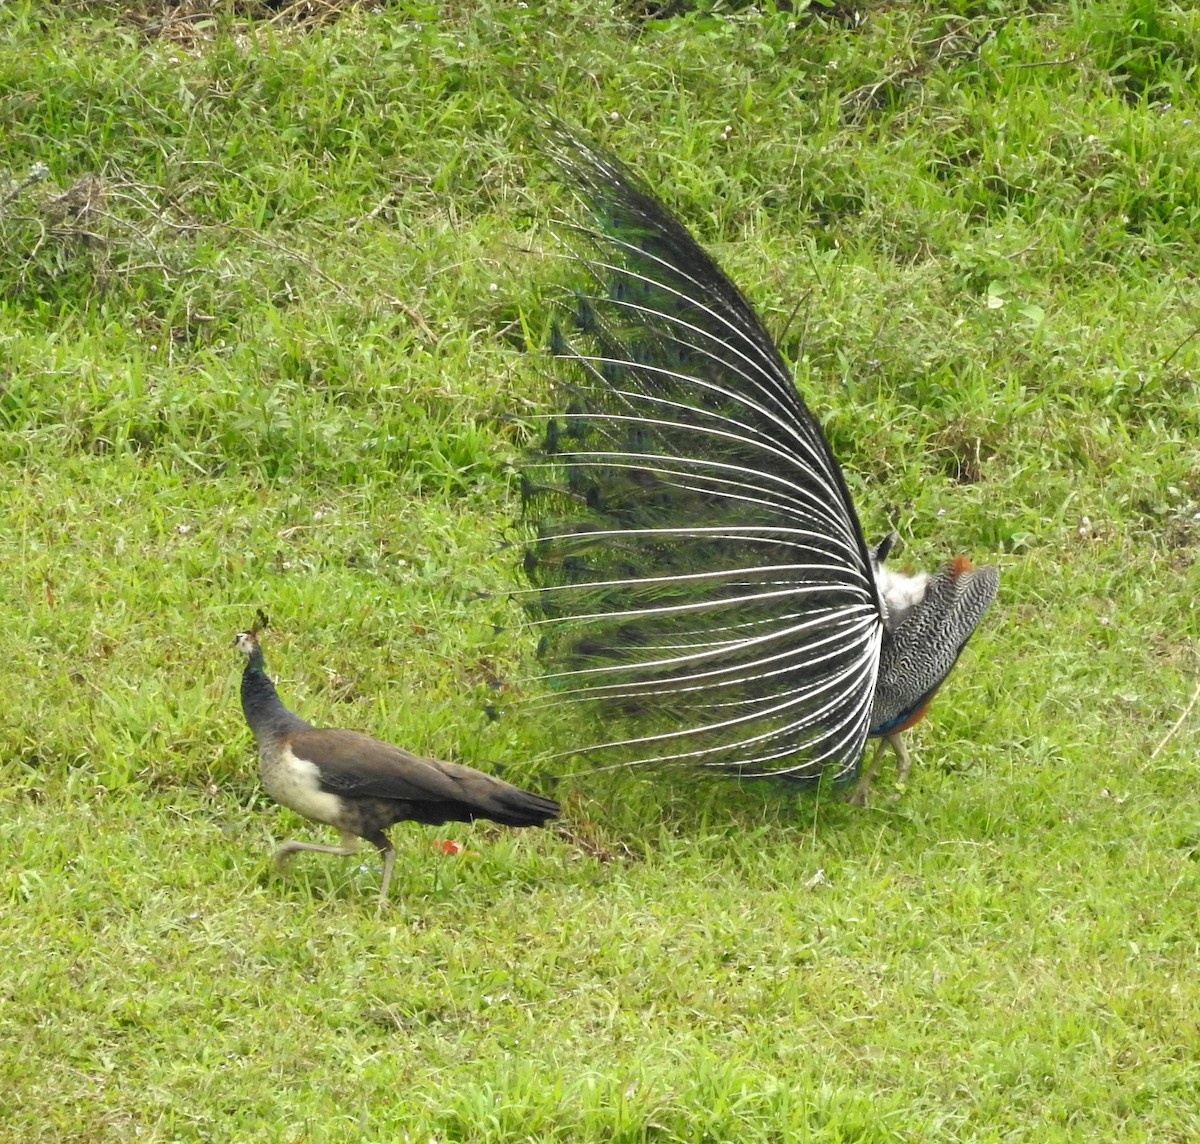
[[0, 0, 1200, 1144]]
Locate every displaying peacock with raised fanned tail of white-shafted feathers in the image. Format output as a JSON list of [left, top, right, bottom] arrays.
[[522, 132, 1000, 803]]
